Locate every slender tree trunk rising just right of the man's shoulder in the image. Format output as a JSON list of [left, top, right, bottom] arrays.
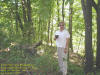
[[69, 2, 73, 51]]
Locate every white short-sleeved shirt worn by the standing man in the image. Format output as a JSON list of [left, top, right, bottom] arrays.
[[55, 29, 70, 48]]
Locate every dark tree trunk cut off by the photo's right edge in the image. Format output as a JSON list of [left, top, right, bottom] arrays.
[[92, 0, 100, 69]]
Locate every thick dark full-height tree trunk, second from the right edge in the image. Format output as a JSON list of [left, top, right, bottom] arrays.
[[81, 0, 93, 74]]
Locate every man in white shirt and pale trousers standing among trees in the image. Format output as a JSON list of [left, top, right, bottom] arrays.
[[54, 22, 70, 75]]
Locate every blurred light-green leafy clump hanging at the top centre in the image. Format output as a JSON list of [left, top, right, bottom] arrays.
[[38, 0, 55, 20]]
